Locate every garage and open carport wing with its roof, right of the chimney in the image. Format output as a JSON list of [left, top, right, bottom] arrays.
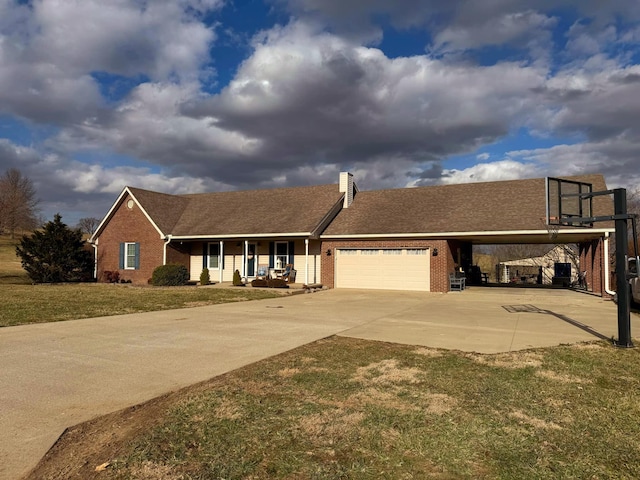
[[320, 175, 614, 295]]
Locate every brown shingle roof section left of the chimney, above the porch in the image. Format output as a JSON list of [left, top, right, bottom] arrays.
[[129, 184, 343, 237]]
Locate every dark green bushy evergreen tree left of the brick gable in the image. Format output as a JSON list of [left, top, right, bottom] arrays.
[[16, 214, 94, 283]]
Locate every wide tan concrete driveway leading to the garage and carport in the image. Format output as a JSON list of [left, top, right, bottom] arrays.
[[0, 288, 640, 479]]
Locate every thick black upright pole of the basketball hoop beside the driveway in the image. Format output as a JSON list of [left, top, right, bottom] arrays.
[[604, 188, 634, 348]]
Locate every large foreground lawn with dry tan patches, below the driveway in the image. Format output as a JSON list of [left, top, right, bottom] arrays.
[[100, 338, 640, 479]]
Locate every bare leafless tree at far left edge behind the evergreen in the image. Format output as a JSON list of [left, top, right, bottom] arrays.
[[0, 168, 39, 238]]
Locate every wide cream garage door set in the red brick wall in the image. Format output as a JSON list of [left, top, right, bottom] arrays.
[[336, 248, 431, 292]]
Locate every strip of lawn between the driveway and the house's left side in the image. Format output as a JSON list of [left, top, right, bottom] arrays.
[[0, 283, 278, 327]]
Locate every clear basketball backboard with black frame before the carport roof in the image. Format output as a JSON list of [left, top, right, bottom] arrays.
[[546, 177, 593, 227]]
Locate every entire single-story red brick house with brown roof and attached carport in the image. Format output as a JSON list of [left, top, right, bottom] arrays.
[[90, 172, 614, 293]]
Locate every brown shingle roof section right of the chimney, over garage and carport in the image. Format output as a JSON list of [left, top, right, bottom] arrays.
[[323, 175, 613, 236]]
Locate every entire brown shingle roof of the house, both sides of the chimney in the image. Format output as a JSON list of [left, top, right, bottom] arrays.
[[122, 175, 613, 237]]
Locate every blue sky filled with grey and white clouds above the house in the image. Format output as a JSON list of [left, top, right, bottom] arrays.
[[0, 0, 640, 225]]
